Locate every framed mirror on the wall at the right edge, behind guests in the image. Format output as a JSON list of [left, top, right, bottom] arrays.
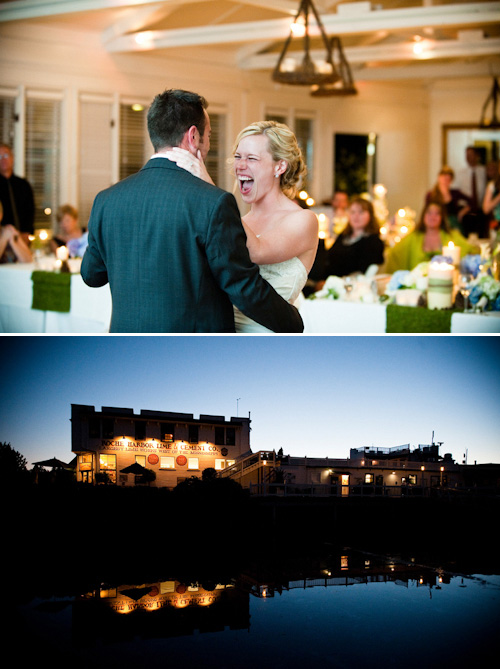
[[442, 124, 500, 172]]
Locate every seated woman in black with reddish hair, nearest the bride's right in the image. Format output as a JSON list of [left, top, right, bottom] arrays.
[[323, 197, 384, 279]]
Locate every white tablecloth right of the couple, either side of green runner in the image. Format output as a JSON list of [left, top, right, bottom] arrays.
[[299, 300, 500, 334]]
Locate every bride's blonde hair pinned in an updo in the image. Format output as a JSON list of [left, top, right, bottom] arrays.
[[229, 121, 307, 200]]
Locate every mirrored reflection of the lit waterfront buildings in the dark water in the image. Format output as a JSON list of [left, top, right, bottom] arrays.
[[73, 549, 451, 646]]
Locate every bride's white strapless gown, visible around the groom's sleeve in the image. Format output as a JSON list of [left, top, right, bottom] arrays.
[[234, 257, 307, 333]]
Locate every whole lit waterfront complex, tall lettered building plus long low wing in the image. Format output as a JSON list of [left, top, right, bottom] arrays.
[[71, 404, 500, 497]]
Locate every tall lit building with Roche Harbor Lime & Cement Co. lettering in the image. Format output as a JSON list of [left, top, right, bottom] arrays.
[[71, 404, 250, 488]]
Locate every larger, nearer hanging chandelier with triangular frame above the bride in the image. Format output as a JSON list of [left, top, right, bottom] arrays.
[[272, 0, 340, 86]]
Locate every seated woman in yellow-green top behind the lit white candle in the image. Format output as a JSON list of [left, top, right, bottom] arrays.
[[385, 202, 478, 274]]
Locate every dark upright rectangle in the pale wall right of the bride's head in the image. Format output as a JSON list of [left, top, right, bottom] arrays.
[[333, 133, 377, 197]]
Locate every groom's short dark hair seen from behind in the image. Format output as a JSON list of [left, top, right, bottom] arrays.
[[148, 88, 208, 151]]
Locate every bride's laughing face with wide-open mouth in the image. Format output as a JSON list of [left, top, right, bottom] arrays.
[[233, 135, 279, 204]]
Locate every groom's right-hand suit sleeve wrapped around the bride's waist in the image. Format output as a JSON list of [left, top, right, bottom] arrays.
[[206, 193, 304, 333]]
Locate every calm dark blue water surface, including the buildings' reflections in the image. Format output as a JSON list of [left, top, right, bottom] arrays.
[[8, 549, 500, 669]]
